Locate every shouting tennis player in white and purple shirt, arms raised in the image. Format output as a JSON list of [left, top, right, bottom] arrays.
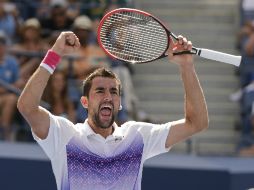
[[18, 32, 208, 190]]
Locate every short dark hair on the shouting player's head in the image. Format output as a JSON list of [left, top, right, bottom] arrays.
[[83, 67, 122, 97]]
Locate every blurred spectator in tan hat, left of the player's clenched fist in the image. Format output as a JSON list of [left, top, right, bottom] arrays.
[[10, 18, 49, 87]]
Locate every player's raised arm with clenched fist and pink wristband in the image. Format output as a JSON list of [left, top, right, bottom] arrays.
[[17, 32, 80, 139]]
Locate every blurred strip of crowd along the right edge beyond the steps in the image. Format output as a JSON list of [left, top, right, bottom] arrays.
[[230, 0, 254, 156]]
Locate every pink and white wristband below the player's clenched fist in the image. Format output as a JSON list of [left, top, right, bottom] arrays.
[[40, 50, 61, 74]]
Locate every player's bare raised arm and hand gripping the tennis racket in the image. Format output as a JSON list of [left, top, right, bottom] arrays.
[[166, 36, 208, 147]]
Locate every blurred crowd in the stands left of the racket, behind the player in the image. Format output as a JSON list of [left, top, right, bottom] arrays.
[[0, 0, 149, 141]]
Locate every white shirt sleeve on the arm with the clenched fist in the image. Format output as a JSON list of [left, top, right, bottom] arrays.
[[32, 109, 75, 160]]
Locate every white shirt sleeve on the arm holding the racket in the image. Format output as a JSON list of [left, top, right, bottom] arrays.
[[128, 122, 171, 159]]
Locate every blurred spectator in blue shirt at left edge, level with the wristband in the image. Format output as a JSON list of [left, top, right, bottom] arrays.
[[0, 31, 20, 140]]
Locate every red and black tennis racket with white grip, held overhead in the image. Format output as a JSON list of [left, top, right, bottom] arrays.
[[97, 8, 241, 66]]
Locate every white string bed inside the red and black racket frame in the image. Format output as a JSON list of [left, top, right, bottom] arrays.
[[100, 12, 168, 62]]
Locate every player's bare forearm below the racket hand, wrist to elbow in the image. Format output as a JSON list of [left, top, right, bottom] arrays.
[[180, 64, 208, 130]]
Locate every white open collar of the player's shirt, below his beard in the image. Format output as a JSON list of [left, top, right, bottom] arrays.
[[84, 119, 124, 141]]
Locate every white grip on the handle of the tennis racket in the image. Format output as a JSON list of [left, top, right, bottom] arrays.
[[197, 48, 242, 67]]
